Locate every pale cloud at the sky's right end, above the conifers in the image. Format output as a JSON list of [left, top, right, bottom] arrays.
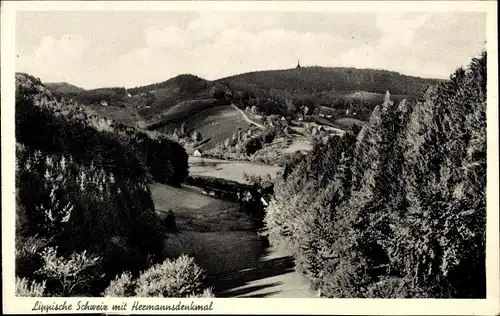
[[342, 13, 486, 78]]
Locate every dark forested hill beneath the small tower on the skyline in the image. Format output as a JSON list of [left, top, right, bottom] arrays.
[[217, 67, 441, 120]]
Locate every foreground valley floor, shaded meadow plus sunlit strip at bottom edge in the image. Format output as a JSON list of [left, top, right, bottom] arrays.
[[151, 184, 314, 298]]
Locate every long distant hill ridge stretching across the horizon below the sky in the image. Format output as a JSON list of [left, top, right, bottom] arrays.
[[51, 67, 441, 143]]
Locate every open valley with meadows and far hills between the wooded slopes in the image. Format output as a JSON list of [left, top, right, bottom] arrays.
[[36, 68, 442, 298]]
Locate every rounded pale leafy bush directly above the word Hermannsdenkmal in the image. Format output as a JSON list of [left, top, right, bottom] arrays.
[[135, 255, 204, 297]]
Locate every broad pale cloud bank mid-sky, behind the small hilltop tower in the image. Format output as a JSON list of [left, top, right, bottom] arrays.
[[105, 13, 378, 85]]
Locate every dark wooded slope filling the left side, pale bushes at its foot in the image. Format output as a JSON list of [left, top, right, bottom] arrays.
[[16, 74, 210, 296]]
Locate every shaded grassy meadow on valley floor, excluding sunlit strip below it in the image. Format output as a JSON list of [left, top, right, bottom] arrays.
[[151, 184, 264, 274]]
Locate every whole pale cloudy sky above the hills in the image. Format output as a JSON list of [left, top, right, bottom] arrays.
[[16, 11, 486, 89]]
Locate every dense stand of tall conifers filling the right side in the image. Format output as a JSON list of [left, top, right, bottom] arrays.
[[265, 53, 486, 298]]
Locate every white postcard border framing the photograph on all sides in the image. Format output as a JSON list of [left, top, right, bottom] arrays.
[[1, 1, 500, 315]]
